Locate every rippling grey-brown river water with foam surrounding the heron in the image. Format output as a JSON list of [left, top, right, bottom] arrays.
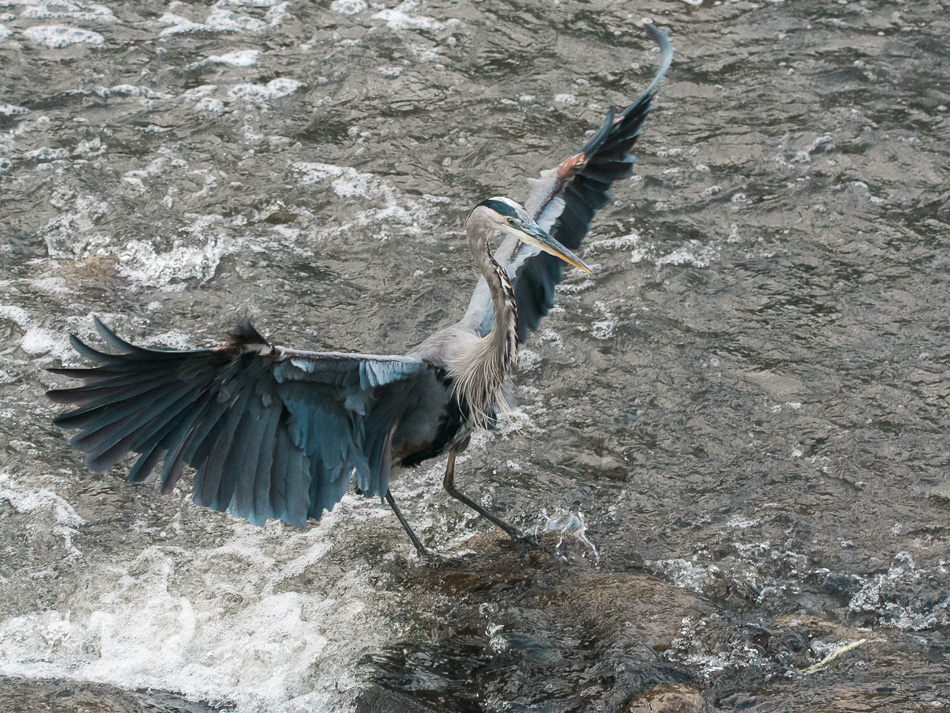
[[0, 0, 950, 713]]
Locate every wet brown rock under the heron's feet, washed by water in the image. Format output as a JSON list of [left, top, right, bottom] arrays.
[[358, 533, 950, 713]]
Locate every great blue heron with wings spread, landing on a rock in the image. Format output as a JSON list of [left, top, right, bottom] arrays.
[[48, 25, 672, 557]]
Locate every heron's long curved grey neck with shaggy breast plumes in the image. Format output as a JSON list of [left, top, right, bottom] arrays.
[[451, 212, 518, 424]]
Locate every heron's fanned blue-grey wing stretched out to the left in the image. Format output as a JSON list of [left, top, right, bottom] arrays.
[[47, 319, 436, 528]]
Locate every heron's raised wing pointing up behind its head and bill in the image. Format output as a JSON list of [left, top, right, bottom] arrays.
[[466, 24, 673, 342]]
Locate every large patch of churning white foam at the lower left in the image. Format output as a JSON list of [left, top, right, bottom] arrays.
[[0, 522, 398, 713]]
